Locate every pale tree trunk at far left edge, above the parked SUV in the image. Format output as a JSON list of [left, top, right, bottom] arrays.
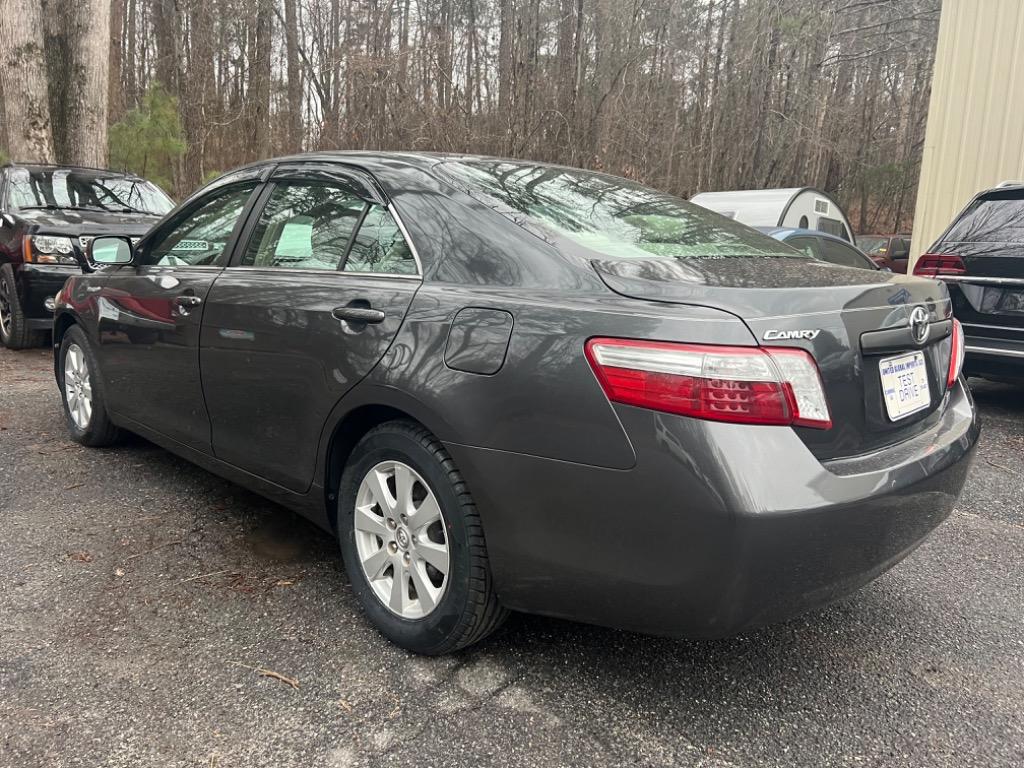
[[0, 0, 53, 163]]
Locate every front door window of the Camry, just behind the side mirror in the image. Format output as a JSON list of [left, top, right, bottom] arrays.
[[136, 183, 256, 266]]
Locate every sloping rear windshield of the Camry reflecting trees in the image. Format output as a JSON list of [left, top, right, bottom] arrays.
[[442, 160, 794, 258]]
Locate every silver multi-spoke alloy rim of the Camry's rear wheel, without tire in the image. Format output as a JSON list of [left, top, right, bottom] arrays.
[[353, 461, 449, 618]]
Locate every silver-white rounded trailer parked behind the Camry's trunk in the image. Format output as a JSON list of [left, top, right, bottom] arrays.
[[690, 186, 853, 243]]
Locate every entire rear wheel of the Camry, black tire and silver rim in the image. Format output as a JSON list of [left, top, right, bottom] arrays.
[[338, 421, 507, 654]]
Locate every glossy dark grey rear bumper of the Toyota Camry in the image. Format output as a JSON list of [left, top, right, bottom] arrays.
[[450, 383, 979, 637]]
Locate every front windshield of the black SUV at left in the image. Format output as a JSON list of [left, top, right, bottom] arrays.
[[8, 168, 174, 215]]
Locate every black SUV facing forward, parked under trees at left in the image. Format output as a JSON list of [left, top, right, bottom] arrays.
[[0, 165, 174, 349]]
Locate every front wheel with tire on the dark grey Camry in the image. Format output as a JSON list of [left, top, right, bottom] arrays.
[[57, 326, 120, 447]]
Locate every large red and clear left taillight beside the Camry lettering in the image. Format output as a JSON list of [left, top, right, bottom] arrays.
[[586, 339, 831, 429]]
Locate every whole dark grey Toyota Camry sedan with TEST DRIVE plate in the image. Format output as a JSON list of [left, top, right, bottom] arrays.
[[53, 153, 978, 653]]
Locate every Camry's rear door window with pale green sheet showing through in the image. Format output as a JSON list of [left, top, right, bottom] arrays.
[[241, 181, 368, 270]]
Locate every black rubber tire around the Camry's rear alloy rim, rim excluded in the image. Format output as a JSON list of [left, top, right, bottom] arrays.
[[337, 421, 508, 655]]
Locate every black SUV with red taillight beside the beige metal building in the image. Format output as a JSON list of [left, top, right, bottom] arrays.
[[913, 185, 1024, 382]]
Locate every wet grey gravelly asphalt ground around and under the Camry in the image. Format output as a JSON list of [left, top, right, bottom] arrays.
[[0, 350, 1024, 768]]
